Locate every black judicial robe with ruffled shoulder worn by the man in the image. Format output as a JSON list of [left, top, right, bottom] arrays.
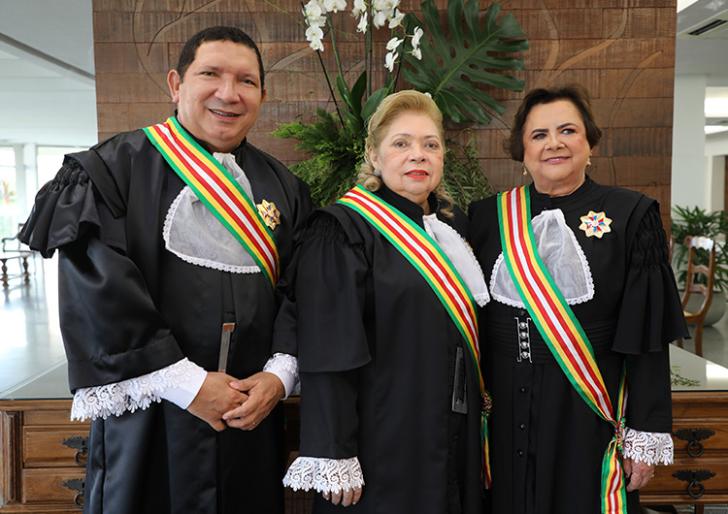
[[22, 130, 310, 514]]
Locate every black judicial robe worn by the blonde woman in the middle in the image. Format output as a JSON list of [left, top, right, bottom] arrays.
[[295, 188, 482, 514]]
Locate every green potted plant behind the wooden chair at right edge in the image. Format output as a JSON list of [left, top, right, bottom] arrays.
[[672, 206, 728, 326]]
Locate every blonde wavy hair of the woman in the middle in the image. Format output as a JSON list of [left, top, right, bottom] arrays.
[[356, 89, 454, 218]]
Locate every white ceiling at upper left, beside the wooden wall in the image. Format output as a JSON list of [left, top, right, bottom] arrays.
[[0, 0, 96, 146]]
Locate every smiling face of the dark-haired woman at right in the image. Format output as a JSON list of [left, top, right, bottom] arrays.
[[523, 100, 591, 196]]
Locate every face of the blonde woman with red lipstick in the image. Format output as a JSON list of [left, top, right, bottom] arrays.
[[369, 111, 445, 210]]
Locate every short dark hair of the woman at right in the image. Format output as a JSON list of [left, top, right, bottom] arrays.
[[505, 85, 602, 162]]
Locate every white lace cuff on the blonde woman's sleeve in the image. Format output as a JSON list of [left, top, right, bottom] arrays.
[[283, 457, 364, 493]]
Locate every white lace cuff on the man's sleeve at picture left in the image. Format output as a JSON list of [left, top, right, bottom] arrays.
[[71, 359, 198, 421]]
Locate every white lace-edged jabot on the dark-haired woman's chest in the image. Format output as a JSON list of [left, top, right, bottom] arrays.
[[490, 209, 594, 307]]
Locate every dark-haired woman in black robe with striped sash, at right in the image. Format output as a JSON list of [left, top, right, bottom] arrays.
[[470, 87, 687, 514]]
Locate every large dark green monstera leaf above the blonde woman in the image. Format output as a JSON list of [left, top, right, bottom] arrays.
[[403, 0, 528, 125]]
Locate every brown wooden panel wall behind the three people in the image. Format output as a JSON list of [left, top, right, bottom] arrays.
[[93, 0, 675, 220]]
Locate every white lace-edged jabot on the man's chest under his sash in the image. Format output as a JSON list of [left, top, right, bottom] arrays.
[[162, 152, 260, 273]]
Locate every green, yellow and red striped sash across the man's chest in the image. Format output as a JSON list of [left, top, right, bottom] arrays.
[[144, 116, 278, 286]]
